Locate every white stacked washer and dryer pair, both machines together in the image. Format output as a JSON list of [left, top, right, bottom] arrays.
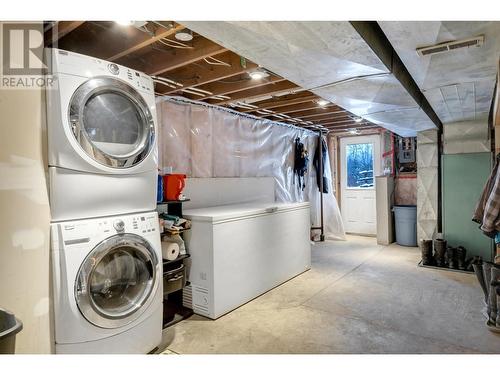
[[46, 49, 163, 353]]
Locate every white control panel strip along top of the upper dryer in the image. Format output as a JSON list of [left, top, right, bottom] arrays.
[[50, 48, 154, 94]]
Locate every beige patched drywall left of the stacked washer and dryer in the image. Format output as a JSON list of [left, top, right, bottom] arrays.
[[0, 23, 52, 353]]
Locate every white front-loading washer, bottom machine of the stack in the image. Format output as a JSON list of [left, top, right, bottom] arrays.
[[51, 212, 163, 353]]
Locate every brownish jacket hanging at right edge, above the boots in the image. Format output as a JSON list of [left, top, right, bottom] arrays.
[[472, 157, 500, 238]]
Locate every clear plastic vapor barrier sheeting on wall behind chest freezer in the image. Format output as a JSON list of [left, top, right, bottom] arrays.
[[157, 96, 345, 239]]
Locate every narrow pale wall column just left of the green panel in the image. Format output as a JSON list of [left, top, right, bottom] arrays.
[[417, 129, 438, 240]]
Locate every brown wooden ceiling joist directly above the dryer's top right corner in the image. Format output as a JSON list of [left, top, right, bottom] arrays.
[[119, 36, 227, 76]]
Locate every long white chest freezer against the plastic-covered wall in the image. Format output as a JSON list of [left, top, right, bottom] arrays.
[[184, 202, 311, 319]]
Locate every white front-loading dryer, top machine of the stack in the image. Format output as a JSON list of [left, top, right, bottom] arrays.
[[45, 49, 158, 221]]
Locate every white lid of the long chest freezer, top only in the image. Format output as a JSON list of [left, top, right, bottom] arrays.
[[183, 202, 310, 223]]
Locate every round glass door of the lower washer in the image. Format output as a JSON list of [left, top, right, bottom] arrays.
[[75, 234, 158, 328]]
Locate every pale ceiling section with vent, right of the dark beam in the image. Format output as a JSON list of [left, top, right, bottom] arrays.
[[379, 21, 500, 123]]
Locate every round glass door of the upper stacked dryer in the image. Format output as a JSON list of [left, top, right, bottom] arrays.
[[69, 77, 155, 168]]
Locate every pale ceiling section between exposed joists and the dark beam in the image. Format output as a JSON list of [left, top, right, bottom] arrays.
[[181, 21, 435, 136]]
